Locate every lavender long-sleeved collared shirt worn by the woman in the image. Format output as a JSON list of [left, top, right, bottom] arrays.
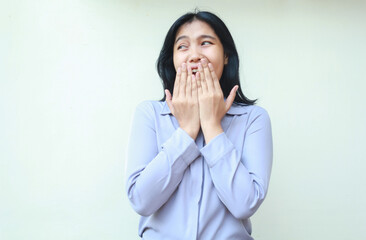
[[126, 101, 272, 240]]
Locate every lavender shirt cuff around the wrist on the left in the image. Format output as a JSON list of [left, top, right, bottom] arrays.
[[163, 128, 201, 166]]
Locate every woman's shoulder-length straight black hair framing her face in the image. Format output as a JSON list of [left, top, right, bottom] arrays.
[[156, 11, 256, 105]]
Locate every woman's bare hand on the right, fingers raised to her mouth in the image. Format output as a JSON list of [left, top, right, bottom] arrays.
[[196, 59, 238, 144]]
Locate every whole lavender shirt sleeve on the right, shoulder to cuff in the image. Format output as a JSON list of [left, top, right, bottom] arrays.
[[201, 108, 273, 219]]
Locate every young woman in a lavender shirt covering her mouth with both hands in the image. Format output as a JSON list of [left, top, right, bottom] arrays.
[[126, 9, 272, 240]]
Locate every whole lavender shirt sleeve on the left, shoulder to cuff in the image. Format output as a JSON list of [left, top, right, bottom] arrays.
[[126, 102, 200, 216]]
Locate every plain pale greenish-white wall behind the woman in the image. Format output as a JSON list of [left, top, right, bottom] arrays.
[[0, 0, 366, 240]]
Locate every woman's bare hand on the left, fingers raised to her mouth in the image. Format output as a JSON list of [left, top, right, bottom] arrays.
[[165, 63, 200, 139]]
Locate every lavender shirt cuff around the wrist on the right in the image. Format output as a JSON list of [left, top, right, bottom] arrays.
[[201, 132, 234, 168]]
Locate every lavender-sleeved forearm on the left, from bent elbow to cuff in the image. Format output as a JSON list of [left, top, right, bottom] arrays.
[[127, 128, 200, 215]]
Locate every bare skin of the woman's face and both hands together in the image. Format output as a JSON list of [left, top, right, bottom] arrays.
[[165, 20, 238, 144]]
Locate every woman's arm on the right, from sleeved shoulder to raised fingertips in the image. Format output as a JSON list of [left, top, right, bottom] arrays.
[[197, 59, 272, 219]]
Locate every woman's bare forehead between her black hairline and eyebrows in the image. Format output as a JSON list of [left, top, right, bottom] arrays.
[[175, 20, 218, 39]]
